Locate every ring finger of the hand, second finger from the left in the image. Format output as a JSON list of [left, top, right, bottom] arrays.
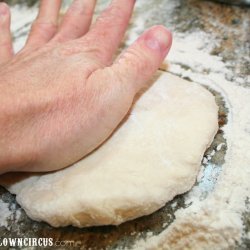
[[26, 0, 61, 47]]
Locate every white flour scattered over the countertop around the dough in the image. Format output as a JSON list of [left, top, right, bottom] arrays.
[[5, 1, 250, 249]]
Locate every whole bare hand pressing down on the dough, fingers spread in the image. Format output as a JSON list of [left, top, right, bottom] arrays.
[[0, 0, 172, 173]]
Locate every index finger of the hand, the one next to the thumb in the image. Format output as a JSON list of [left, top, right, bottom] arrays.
[[84, 0, 135, 64]]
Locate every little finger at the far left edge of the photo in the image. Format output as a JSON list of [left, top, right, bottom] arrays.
[[0, 2, 13, 64]]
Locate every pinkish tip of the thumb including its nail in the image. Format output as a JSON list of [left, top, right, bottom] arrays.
[[146, 26, 172, 54]]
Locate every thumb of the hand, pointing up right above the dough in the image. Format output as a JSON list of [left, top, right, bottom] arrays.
[[107, 26, 172, 93]]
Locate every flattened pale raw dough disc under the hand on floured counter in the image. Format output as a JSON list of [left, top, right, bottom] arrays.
[[0, 73, 218, 227]]
